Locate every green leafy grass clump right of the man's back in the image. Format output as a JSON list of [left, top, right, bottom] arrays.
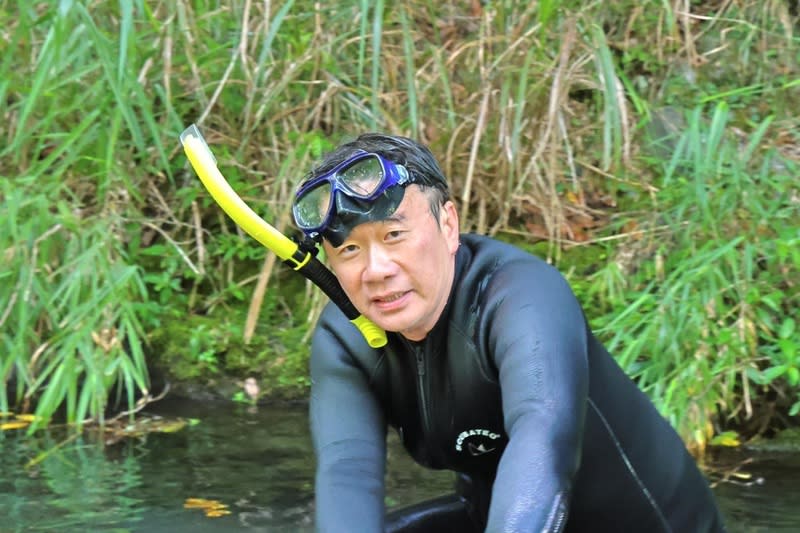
[[590, 104, 800, 449]]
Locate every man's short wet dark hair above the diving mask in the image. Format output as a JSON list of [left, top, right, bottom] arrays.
[[306, 133, 450, 222]]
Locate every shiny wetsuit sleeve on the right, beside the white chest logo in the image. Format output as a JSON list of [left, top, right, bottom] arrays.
[[483, 261, 588, 532]]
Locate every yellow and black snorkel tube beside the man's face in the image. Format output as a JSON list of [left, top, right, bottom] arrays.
[[180, 124, 386, 348]]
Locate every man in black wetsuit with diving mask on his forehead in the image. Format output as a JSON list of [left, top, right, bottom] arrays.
[[293, 134, 723, 533]]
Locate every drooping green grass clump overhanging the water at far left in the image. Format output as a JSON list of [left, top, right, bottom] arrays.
[[0, 172, 149, 429]]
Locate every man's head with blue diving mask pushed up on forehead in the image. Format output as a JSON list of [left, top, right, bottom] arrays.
[[293, 133, 458, 340]]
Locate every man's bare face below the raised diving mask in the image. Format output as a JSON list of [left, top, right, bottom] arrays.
[[323, 185, 459, 341]]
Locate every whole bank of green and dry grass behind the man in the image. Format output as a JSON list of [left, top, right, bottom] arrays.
[[0, 0, 800, 447]]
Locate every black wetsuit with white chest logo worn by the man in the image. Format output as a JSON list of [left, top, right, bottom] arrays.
[[311, 235, 723, 533]]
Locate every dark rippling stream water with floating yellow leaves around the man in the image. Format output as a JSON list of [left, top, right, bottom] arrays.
[[0, 400, 800, 533]]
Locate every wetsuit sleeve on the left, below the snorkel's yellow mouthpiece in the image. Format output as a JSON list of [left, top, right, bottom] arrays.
[[310, 305, 386, 533]]
